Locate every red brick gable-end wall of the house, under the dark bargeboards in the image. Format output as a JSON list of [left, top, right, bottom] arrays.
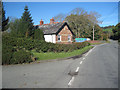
[[56, 25, 73, 44]]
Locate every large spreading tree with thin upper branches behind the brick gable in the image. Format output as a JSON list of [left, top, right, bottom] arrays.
[[54, 8, 108, 40]]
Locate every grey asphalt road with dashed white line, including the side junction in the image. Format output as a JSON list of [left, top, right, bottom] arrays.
[[2, 41, 118, 88]]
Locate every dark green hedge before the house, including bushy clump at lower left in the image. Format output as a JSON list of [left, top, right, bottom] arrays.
[[2, 35, 90, 64]]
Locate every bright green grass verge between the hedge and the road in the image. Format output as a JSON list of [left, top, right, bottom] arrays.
[[32, 46, 93, 60]]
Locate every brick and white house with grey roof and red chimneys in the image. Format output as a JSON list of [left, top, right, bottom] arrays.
[[34, 18, 74, 44]]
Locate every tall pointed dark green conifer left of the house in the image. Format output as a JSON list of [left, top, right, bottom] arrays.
[[10, 6, 34, 37]]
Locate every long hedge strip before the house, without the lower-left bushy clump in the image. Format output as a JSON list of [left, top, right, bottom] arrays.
[[3, 36, 90, 52]]
